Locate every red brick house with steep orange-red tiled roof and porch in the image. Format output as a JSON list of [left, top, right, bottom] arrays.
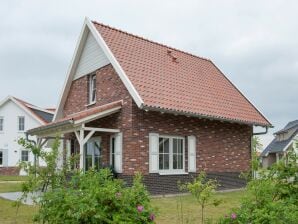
[[28, 18, 271, 194]]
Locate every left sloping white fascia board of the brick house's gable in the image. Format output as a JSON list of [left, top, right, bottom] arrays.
[[53, 20, 89, 121]]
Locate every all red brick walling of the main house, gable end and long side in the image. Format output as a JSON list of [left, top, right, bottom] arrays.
[[64, 65, 252, 175]]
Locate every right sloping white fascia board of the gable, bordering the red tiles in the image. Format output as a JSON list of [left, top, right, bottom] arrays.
[[85, 18, 144, 108]]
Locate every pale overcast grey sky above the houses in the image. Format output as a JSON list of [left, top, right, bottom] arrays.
[[0, 0, 298, 146]]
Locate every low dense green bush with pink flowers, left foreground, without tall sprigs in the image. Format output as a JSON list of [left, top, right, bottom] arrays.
[[35, 169, 155, 224]]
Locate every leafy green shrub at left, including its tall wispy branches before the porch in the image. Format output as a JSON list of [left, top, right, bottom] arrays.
[[17, 139, 155, 224]]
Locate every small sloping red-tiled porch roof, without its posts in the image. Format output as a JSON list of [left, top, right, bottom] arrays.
[[27, 100, 123, 137]]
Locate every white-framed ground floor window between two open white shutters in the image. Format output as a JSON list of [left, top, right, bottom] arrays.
[[158, 136, 184, 171]]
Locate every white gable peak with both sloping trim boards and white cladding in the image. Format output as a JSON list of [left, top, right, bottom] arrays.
[[53, 18, 144, 121]]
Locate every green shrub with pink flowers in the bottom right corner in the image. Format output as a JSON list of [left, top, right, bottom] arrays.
[[219, 152, 298, 224]]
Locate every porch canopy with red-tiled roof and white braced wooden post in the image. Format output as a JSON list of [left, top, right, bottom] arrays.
[[27, 100, 123, 168]]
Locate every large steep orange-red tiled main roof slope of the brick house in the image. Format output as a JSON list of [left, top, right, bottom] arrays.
[[93, 22, 271, 126]]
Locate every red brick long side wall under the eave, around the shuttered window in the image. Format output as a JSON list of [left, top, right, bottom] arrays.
[[124, 105, 252, 173]]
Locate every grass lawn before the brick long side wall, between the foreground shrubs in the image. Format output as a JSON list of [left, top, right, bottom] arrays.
[[152, 191, 244, 224]]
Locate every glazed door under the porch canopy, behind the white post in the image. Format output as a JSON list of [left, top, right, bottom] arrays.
[[84, 137, 102, 171]]
